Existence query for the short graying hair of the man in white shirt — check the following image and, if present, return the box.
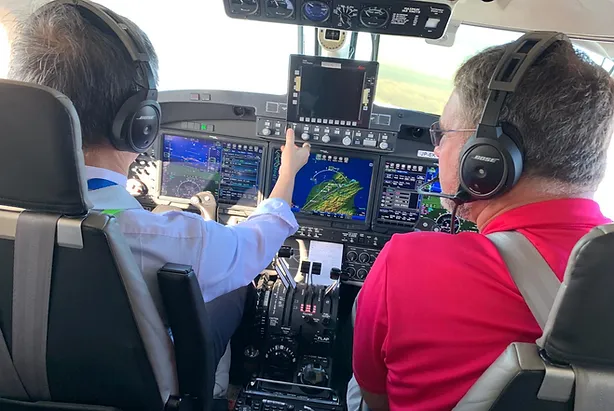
[9,4,158,147]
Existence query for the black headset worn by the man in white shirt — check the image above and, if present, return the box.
[48,0,161,153]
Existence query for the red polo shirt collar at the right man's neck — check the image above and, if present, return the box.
[482,198,610,234]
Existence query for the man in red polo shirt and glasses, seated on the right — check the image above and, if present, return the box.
[353,37,614,411]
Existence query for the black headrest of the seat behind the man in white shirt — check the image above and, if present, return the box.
[0,80,89,215]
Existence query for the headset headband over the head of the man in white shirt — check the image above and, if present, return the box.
[47,0,158,94]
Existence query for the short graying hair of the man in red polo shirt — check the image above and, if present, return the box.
[455,42,614,191]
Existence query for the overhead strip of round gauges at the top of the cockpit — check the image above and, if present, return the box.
[223,0,452,39]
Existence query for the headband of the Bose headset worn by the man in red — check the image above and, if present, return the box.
[476,32,570,138]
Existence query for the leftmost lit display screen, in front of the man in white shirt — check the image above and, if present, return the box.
[160,134,263,207]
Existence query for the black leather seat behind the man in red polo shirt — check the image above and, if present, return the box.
[455,224,614,411]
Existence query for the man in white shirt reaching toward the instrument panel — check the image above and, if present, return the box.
[8,2,309,400]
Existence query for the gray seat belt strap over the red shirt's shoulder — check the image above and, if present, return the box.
[486,231,561,330]
